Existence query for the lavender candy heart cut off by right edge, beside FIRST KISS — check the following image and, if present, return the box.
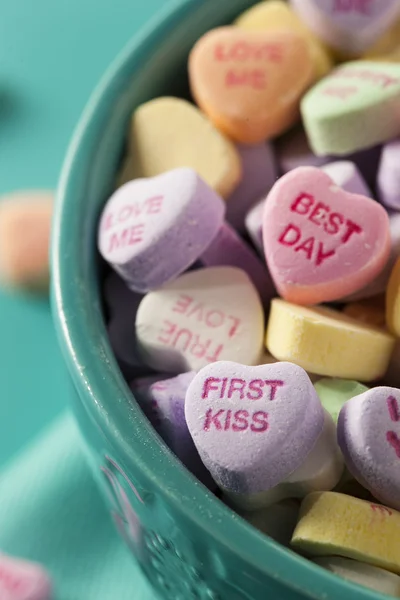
[337,387,400,510]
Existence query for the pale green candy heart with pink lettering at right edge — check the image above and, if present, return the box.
[301,61,400,155]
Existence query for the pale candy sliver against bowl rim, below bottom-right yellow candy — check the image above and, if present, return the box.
[314,556,400,597]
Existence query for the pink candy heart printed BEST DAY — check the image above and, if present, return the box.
[263,167,390,305]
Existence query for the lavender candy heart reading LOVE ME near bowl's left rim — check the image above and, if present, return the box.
[98,168,225,293]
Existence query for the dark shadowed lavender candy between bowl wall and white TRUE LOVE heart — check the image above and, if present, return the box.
[104,272,152,379]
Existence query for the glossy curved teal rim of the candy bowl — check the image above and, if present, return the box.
[51,0,386,600]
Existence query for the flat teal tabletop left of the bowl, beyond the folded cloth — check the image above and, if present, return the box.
[0,0,169,467]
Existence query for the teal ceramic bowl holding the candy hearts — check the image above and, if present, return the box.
[52,0,384,600]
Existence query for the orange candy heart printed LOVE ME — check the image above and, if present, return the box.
[189,27,314,144]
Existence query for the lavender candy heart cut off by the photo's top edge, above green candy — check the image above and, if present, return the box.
[290,0,400,55]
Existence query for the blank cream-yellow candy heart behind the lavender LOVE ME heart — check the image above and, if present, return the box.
[125,97,241,198]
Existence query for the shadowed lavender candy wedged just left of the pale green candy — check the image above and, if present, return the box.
[276,127,330,174]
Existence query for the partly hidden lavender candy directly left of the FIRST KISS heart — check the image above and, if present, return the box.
[131,371,216,489]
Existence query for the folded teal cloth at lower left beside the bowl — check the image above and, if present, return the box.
[0,414,155,600]
